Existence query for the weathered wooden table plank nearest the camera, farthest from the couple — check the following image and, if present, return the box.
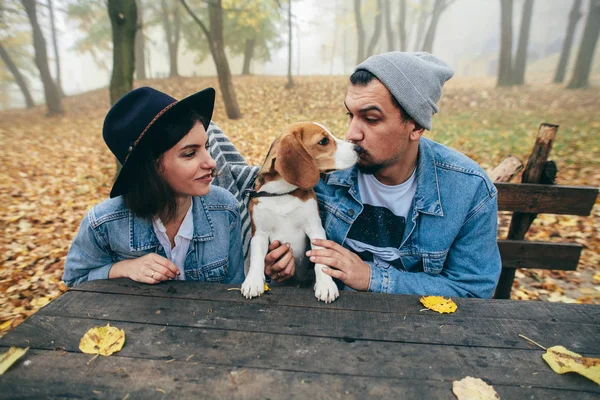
[0,350,598,400]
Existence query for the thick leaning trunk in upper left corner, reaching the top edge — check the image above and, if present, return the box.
[21,0,63,115]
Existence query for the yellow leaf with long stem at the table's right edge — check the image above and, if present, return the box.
[542,346,600,385]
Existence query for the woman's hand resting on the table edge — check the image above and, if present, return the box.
[108,253,179,285]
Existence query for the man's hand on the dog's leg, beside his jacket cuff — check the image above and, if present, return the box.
[306,239,371,291]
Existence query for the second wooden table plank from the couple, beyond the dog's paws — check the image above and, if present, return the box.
[29,292,600,353]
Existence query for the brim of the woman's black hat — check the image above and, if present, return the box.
[110,88,215,198]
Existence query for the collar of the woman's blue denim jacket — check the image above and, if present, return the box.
[129,197,214,251]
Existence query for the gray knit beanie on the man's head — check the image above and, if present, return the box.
[355,51,454,130]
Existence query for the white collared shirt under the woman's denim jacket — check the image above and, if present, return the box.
[152,204,194,281]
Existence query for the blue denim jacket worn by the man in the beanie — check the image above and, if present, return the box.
[315,138,501,298]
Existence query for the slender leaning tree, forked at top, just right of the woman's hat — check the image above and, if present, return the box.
[181,0,242,119]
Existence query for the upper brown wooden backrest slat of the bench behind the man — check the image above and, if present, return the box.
[495,183,598,216]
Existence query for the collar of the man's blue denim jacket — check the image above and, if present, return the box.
[325,137,444,217]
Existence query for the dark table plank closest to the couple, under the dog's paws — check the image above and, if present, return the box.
[68,279,600,324]
